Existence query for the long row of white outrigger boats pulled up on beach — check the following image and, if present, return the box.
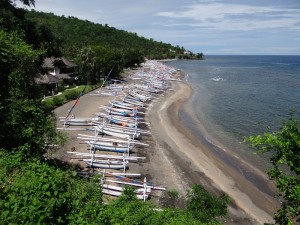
[61,61,180,201]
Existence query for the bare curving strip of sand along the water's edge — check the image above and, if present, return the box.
[149,74,277,224]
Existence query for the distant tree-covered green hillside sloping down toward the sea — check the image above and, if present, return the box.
[26,10,195,60]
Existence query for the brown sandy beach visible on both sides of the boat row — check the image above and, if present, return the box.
[55,63,278,224]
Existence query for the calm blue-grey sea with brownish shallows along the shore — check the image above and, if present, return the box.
[166,55,300,192]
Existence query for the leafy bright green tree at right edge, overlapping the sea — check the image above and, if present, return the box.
[245,114,300,225]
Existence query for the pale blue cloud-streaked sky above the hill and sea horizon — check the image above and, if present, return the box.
[18,0,300,55]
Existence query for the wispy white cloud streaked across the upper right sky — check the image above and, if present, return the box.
[157,2,300,30]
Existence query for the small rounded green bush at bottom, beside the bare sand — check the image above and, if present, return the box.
[187,184,230,223]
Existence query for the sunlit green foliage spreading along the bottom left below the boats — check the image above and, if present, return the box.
[0,151,226,225]
